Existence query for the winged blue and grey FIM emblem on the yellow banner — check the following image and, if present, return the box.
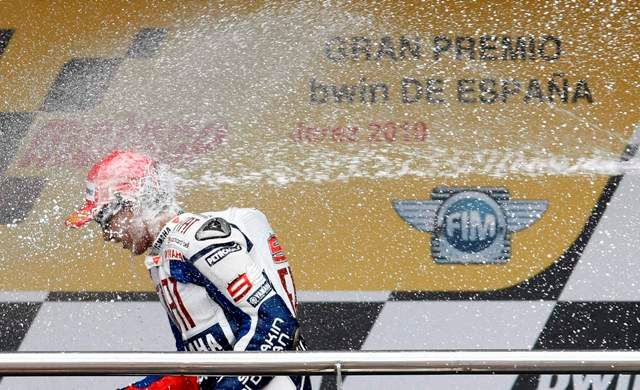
[393,187,549,264]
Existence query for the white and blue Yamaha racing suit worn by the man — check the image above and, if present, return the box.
[136,208,311,390]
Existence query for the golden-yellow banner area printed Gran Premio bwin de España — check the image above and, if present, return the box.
[0,1,640,299]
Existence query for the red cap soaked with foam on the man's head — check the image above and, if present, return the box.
[64,150,155,229]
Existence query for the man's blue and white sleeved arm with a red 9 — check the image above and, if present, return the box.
[190,222,298,389]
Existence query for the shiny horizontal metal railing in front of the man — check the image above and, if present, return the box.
[0,351,640,388]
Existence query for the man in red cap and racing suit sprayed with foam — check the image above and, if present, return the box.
[65,151,310,389]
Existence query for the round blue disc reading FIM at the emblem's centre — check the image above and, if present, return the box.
[443,196,499,253]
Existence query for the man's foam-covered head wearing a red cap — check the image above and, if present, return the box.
[65,150,178,255]
